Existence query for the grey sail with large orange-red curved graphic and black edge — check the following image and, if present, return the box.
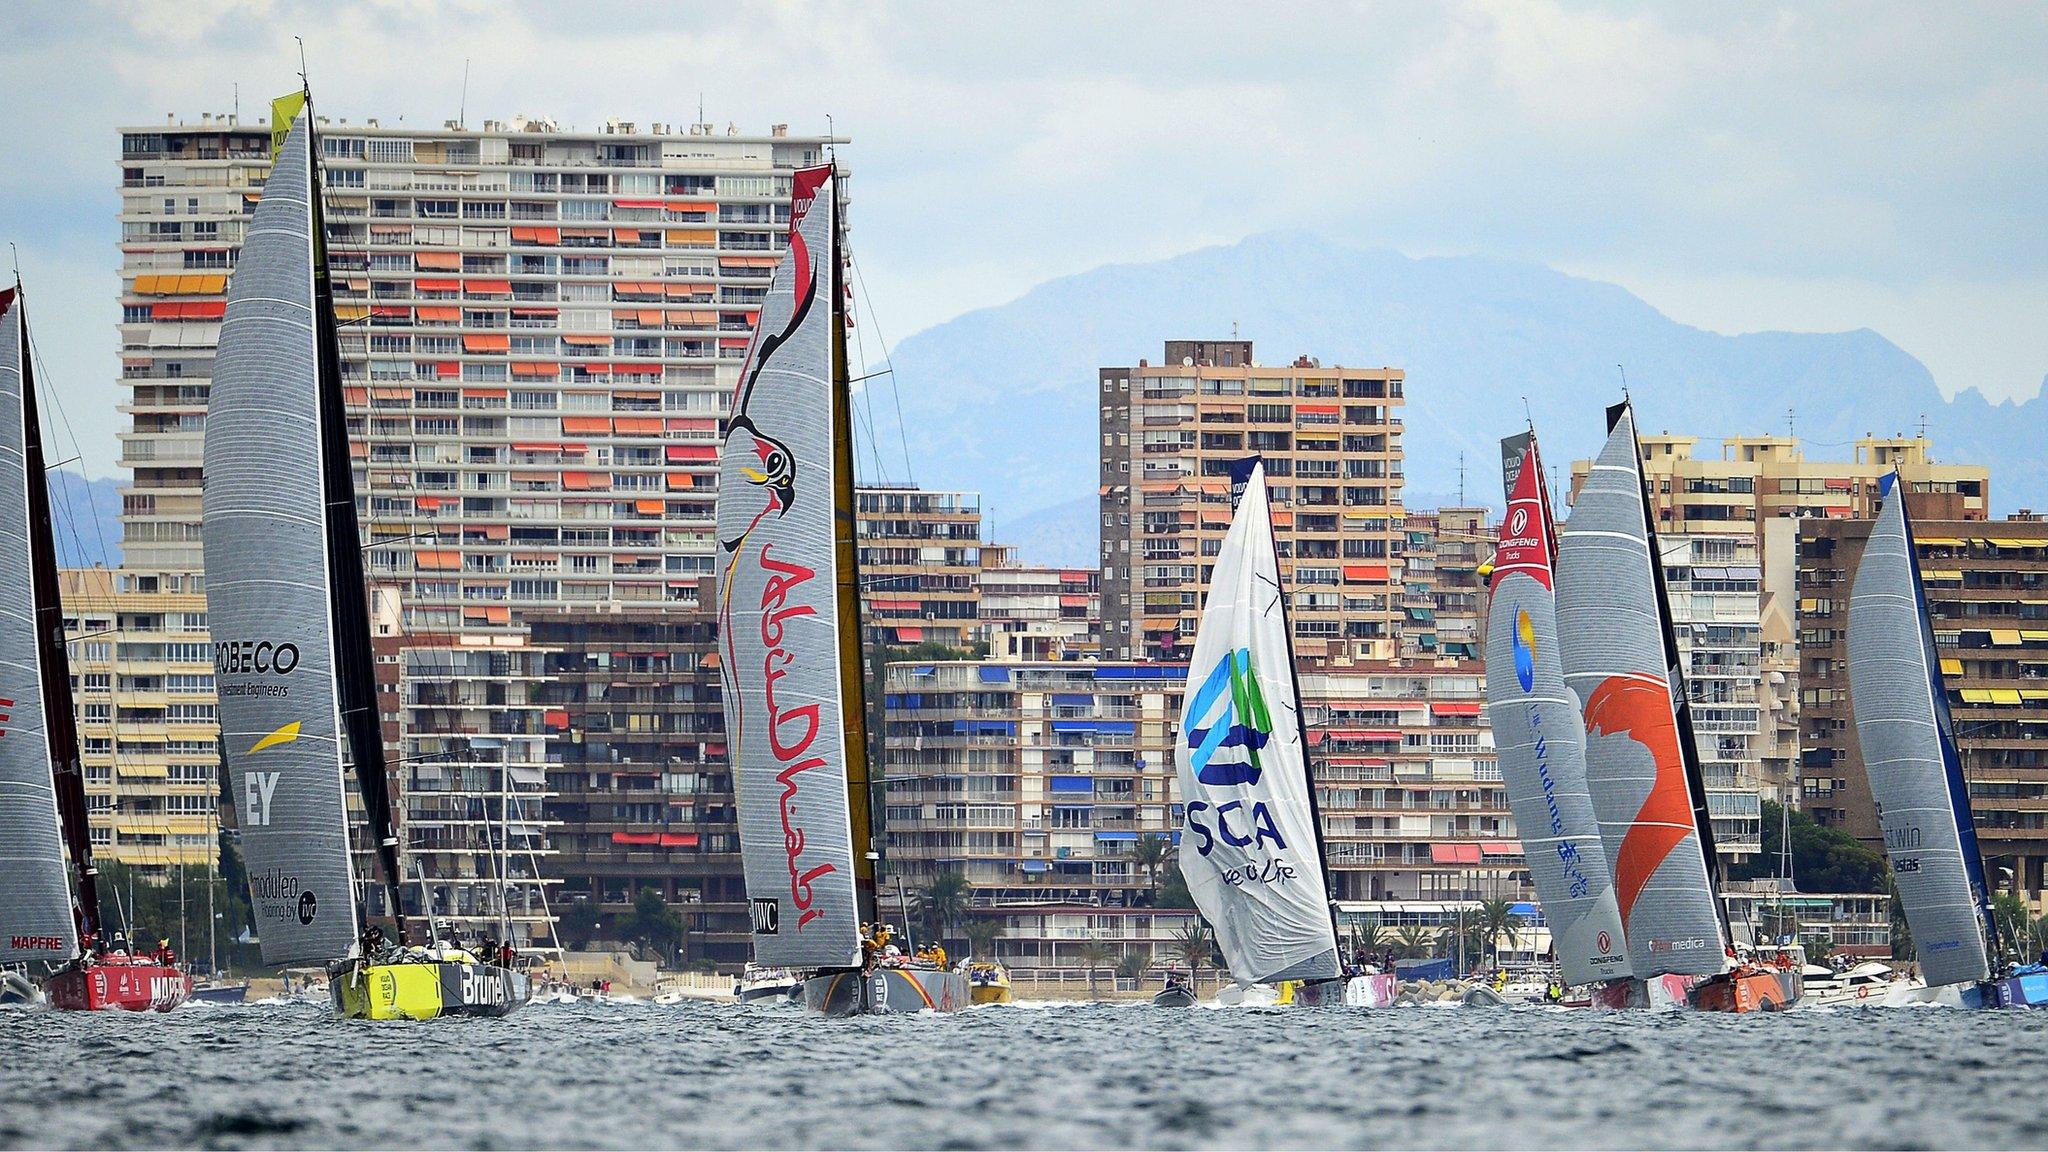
[1556,404,1729,978]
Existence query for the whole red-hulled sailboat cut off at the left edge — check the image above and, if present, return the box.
[0,281,193,1011]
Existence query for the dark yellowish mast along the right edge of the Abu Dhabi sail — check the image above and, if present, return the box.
[827,164,880,929]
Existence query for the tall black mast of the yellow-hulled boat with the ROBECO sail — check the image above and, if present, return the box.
[305,88,407,943]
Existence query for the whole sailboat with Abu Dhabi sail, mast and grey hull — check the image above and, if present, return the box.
[719,164,971,1017]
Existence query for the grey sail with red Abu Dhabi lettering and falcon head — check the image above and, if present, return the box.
[719,168,864,968]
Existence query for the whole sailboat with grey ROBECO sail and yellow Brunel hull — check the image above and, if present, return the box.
[203,90,532,1019]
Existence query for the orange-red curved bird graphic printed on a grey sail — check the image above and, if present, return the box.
[1585,676,1694,924]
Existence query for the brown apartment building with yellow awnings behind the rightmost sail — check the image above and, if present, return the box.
[1798,518,2048,900]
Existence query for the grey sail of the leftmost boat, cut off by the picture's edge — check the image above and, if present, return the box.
[0,289,90,963]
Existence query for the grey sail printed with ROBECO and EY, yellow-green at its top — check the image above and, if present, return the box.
[203,100,362,963]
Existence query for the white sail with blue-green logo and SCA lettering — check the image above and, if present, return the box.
[1174,457,1341,984]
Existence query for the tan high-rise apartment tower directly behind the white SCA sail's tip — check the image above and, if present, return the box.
[1098,340,1405,664]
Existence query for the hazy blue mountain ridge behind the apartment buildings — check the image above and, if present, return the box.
[870,232,2048,564]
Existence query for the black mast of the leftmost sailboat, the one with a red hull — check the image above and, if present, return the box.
[13,279,100,945]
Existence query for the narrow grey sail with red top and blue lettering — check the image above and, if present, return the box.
[1487,435,1630,984]
